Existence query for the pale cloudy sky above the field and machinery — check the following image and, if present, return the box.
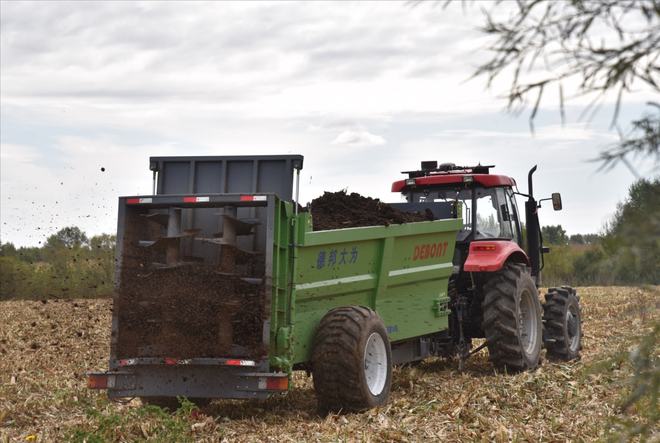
[0,1,657,246]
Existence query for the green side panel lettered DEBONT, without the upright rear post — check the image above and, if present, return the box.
[293,215,461,362]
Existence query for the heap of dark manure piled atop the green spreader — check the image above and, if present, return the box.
[311,191,433,231]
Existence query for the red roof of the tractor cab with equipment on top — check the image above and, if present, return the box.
[392,161,516,192]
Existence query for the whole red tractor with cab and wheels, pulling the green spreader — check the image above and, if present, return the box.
[392,161,582,372]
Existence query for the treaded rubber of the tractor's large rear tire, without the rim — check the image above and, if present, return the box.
[481,263,540,372]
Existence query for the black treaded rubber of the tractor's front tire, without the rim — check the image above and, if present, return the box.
[543,286,582,361]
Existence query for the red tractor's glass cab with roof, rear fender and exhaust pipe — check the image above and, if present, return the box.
[392,161,561,284]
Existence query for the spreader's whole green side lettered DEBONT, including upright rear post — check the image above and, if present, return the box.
[270,201,462,371]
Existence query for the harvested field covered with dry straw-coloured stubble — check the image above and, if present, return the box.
[0,287,660,442]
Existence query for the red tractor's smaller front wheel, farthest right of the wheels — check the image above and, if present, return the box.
[543,286,582,361]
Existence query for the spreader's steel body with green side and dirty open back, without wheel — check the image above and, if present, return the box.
[89,156,462,400]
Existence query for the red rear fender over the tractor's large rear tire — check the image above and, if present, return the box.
[463,240,530,272]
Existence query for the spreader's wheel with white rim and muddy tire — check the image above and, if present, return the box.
[312,306,392,414]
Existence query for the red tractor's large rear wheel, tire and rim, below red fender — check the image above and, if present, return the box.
[481,263,543,372]
